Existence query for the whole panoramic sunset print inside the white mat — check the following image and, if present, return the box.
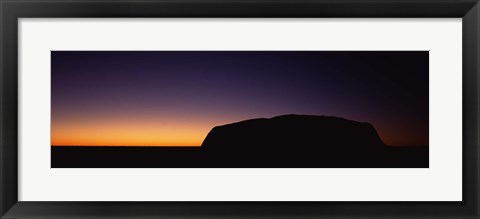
[51,51,429,168]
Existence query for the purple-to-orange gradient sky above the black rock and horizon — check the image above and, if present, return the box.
[51,51,428,146]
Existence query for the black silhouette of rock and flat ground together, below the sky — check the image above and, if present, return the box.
[52,115,429,168]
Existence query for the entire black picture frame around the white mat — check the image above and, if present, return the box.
[0,0,480,219]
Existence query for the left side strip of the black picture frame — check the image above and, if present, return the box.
[0,2,18,215]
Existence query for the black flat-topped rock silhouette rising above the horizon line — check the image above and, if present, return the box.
[202,115,384,150]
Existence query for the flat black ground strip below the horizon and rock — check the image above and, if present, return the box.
[51,146,429,168]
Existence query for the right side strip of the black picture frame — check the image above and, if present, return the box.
[462,3,480,217]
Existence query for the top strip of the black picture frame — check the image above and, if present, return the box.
[2,0,478,18]
